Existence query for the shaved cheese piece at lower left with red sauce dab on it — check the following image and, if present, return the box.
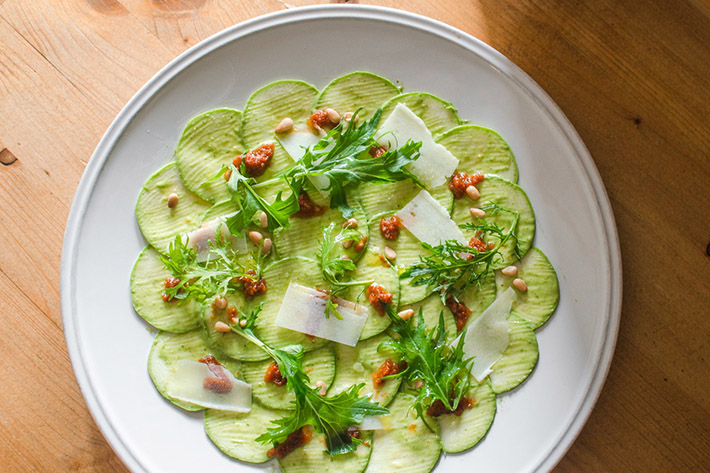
[166,360,251,412]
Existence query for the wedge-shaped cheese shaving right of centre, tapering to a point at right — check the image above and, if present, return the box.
[396,190,466,246]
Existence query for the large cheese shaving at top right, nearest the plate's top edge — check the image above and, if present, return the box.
[377,103,459,187]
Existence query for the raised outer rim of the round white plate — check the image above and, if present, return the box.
[60,5,622,473]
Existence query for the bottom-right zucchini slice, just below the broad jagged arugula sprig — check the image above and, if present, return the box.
[436,380,497,453]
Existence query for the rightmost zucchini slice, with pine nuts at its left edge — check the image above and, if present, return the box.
[496,247,560,329]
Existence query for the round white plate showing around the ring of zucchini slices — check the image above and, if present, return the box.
[61,5,621,473]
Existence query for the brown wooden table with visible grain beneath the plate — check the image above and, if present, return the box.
[0,0,710,472]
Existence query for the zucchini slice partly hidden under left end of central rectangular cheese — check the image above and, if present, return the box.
[249,256,328,351]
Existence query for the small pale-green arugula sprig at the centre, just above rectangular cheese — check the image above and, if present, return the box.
[316,222,373,319]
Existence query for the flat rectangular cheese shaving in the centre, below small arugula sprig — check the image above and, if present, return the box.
[276,282,367,347]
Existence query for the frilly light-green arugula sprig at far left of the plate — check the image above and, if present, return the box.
[158,227,263,302]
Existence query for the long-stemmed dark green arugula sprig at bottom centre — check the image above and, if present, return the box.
[231,306,389,455]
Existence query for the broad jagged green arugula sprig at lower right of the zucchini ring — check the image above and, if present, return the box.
[382,307,473,423]
